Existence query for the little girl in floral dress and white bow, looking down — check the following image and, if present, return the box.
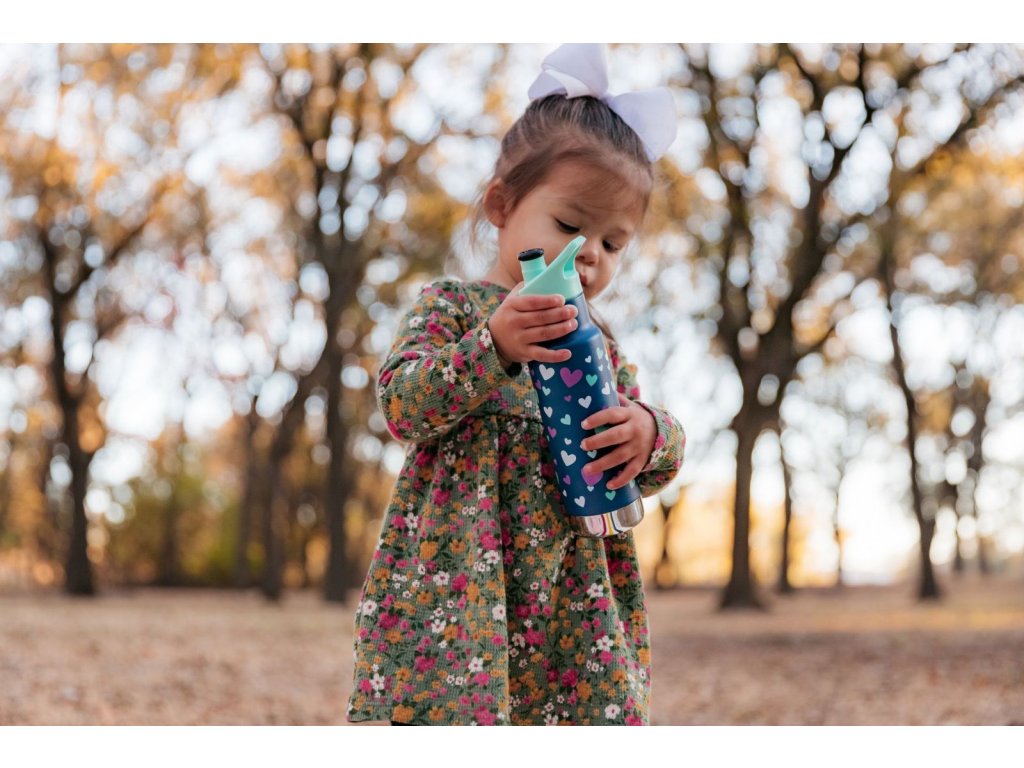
[348,45,685,725]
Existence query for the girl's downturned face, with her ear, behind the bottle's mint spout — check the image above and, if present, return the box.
[484,161,643,300]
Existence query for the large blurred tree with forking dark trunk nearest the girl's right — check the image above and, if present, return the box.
[680,44,1020,607]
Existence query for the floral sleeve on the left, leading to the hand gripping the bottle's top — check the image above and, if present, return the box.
[377,280,514,442]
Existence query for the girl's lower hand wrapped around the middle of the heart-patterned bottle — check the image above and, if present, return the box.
[580,392,657,490]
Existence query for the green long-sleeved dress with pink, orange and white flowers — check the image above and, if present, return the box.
[347,280,685,725]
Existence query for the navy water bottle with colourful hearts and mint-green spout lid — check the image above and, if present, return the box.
[519,237,643,539]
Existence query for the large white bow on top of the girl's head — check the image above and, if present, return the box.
[528,43,676,163]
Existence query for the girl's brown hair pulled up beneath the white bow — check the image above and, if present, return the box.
[468,94,654,339]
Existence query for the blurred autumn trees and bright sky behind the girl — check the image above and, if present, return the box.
[0,44,1024,723]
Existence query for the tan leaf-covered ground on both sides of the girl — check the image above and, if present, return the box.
[0,577,1024,725]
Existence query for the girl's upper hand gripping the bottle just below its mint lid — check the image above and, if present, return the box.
[487,283,577,362]
